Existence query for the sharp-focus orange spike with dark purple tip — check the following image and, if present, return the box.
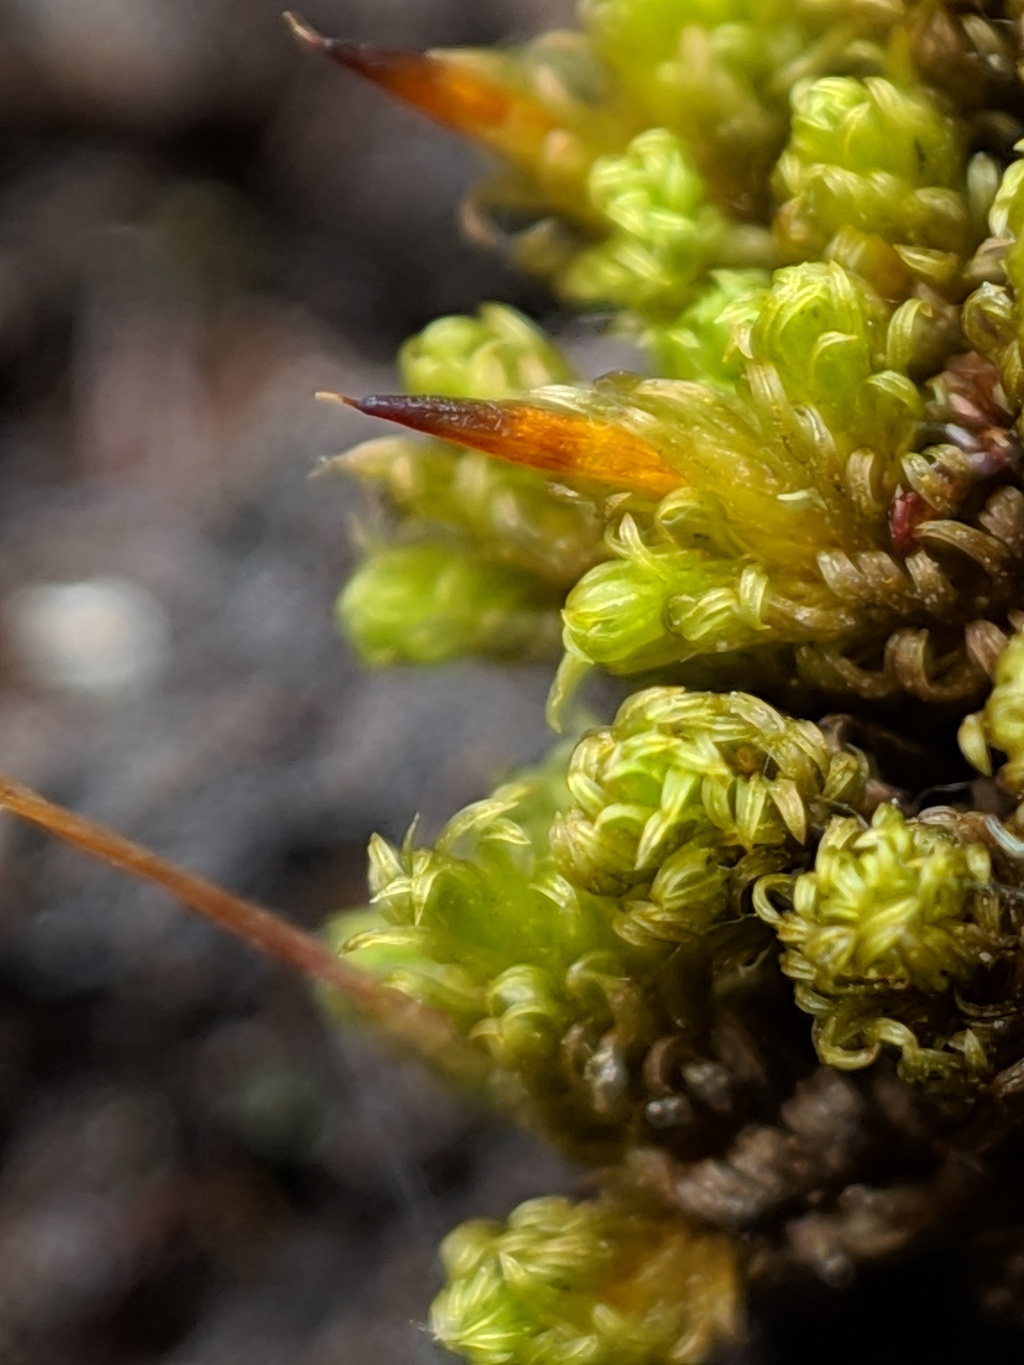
[344,393,683,497]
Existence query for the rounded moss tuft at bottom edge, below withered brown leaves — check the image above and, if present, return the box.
[430,1197,740,1365]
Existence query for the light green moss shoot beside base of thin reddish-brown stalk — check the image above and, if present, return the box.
[333,751,638,1144]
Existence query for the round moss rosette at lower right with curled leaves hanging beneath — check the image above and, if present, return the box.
[755,805,1008,1080]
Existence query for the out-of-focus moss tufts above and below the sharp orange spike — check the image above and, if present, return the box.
[337,303,602,665]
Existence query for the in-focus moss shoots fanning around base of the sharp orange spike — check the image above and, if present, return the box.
[565,263,945,693]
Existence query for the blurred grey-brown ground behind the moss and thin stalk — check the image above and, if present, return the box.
[0,0,584,1365]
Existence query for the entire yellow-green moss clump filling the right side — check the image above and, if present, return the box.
[320,0,1024,1365]
